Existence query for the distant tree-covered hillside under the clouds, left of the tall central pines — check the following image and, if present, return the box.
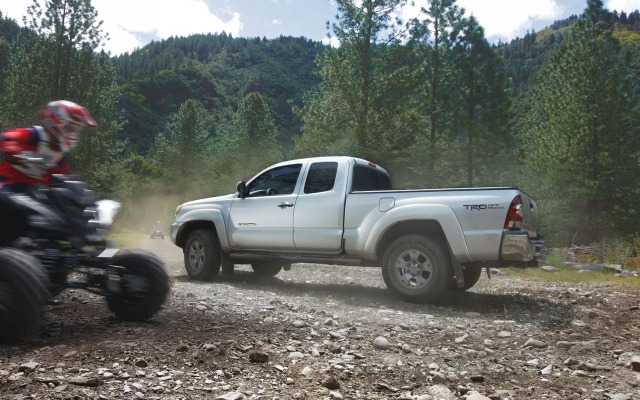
[113,33,322,154]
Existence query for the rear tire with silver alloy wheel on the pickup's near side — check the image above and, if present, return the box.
[382,235,453,303]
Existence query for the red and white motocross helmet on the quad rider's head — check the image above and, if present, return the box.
[40,100,97,149]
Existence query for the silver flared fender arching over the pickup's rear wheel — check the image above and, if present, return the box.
[364,204,471,263]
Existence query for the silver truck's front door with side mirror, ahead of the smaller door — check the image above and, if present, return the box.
[229,164,302,250]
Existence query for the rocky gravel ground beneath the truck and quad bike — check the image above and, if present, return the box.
[0,239,640,400]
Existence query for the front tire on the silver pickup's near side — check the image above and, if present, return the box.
[183,229,221,281]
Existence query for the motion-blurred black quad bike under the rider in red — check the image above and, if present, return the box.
[0,171,169,342]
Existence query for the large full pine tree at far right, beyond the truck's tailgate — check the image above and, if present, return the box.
[524,0,640,244]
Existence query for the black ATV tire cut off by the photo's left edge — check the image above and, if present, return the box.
[0,248,50,342]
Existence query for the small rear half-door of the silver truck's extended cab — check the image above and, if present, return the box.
[293,161,348,254]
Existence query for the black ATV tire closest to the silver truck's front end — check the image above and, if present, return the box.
[107,250,169,321]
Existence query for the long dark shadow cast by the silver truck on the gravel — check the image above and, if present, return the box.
[175,271,576,329]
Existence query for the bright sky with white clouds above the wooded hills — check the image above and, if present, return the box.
[0,0,640,56]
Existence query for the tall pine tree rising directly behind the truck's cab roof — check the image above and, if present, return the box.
[296,0,410,160]
